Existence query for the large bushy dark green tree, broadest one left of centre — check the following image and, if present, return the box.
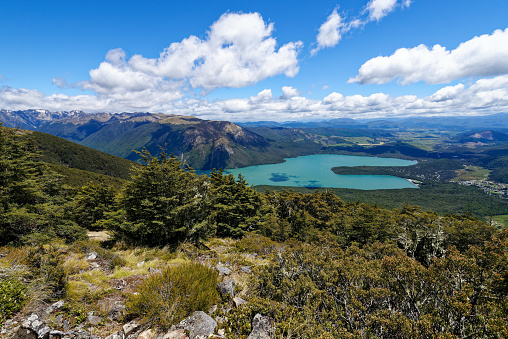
[103,150,211,246]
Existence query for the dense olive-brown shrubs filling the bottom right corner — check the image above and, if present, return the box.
[251,238,508,338]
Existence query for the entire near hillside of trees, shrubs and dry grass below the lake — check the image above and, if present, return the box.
[0,126,508,338]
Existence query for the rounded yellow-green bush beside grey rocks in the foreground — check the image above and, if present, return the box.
[127,262,219,329]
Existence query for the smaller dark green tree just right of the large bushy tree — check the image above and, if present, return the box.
[208,170,264,238]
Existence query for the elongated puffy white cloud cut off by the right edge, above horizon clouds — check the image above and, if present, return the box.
[348,28,508,85]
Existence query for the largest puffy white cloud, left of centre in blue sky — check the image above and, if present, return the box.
[81,13,302,94]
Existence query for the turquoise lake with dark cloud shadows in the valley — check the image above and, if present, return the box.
[225,154,417,190]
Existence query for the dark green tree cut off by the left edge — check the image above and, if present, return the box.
[0,124,86,245]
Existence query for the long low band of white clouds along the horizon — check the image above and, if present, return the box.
[0,75,508,121]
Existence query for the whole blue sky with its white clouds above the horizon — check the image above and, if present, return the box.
[0,0,508,122]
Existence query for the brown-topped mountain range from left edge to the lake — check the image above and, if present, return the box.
[0,110,283,169]
